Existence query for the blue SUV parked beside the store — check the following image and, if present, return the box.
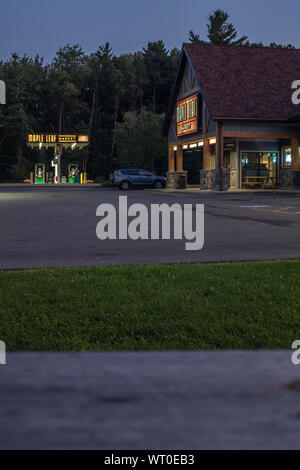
[110,168,167,190]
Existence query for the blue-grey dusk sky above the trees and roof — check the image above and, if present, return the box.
[0,0,300,61]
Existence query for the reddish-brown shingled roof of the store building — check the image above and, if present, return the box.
[176,43,300,120]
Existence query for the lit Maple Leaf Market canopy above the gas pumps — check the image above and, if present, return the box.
[27,134,89,148]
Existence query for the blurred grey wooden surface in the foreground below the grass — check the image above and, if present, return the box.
[0,351,300,449]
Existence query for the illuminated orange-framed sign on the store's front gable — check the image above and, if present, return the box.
[177,95,199,136]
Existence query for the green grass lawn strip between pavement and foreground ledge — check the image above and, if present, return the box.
[0,261,300,351]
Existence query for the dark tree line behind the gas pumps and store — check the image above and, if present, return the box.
[0,10,293,182]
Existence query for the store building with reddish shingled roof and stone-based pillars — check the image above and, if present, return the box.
[165,44,300,191]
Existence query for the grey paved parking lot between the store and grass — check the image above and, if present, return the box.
[0,187,300,269]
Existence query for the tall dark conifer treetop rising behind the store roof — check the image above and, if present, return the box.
[189,9,247,46]
